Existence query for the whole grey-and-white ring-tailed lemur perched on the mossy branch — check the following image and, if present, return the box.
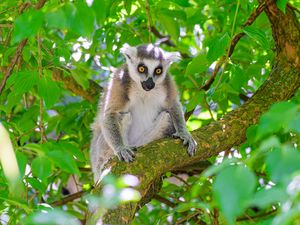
[90,44,197,182]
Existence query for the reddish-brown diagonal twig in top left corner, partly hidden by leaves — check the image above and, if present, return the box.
[0,0,46,95]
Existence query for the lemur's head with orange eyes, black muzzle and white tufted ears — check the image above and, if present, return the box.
[121,44,180,91]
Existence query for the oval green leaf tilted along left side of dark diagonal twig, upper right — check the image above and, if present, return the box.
[207,33,230,62]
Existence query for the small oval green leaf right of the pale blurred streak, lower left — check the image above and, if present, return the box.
[31,156,52,182]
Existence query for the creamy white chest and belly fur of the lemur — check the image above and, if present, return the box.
[126,84,166,146]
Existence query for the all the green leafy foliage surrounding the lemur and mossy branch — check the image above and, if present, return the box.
[0,0,300,224]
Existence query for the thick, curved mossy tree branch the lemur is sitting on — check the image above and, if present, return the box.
[88,0,300,225]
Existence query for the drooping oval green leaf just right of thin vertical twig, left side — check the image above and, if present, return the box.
[38,77,61,108]
